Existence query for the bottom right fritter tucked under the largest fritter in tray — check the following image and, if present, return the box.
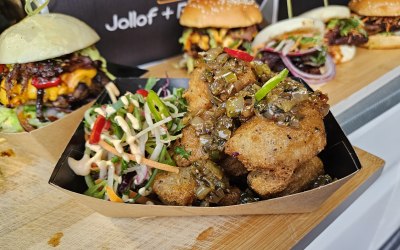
[247,157,324,198]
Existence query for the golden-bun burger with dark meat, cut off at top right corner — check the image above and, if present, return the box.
[349,0,400,49]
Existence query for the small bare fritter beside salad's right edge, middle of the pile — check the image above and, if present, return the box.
[172,125,208,167]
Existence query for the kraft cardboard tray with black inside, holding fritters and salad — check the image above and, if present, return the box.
[49,78,361,217]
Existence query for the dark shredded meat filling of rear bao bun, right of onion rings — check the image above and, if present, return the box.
[325,27,368,46]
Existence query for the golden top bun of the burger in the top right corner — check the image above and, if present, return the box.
[349,0,400,16]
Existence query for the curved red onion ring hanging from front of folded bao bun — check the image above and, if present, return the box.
[279,55,336,84]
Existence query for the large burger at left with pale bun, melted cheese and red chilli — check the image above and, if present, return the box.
[0,13,114,133]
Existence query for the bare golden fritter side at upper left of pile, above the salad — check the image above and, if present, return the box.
[183,67,212,116]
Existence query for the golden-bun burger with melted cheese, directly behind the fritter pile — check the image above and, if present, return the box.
[179,0,263,72]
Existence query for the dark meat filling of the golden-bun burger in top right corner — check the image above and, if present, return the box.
[361,16,400,35]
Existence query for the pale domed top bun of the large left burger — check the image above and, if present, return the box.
[0,13,100,64]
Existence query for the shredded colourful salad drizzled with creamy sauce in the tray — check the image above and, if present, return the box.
[68,79,187,204]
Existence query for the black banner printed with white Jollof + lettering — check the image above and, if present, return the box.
[49,0,186,66]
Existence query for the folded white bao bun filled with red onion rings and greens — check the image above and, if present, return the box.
[252,17,335,84]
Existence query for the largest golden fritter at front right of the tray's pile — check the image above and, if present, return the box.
[225,104,326,171]
